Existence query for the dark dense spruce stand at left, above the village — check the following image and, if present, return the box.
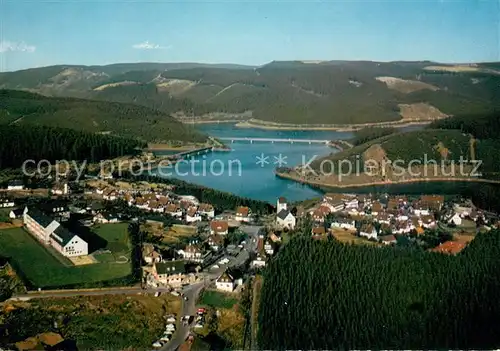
[0,124,144,168]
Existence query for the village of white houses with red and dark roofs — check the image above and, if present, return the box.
[0,177,498,348]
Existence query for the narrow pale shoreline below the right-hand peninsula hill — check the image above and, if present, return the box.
[274,171,500,189]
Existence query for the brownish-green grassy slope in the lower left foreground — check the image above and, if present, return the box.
[0,294,181,350]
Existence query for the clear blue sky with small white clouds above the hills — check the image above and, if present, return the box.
[0,0,500,71]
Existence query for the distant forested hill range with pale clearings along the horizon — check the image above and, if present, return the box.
[0,61,500,124]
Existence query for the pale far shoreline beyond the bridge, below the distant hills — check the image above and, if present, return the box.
[235,120,433,132]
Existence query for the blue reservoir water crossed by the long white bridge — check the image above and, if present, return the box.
[160,124,421,203]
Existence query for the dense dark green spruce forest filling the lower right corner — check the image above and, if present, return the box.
[258,230,500,350]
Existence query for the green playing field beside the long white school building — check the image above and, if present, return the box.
[0,224,131,288]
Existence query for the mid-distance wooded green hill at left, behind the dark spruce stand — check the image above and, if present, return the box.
[0,90,206,142]
